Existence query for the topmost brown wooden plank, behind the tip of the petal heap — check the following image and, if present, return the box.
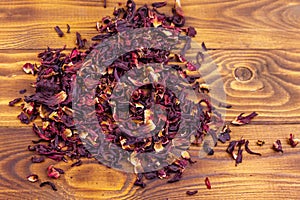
[0,0,300,49]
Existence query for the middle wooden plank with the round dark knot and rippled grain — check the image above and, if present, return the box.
[0,50,300,126]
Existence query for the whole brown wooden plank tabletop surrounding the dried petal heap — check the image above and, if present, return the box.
[0,0,300,199]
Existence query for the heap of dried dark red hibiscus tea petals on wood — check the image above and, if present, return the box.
[18,0,225,190]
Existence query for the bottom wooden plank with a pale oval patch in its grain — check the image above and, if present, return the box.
[0,124,300,199]
